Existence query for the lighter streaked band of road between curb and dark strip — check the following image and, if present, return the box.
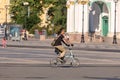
[0,47,120,66]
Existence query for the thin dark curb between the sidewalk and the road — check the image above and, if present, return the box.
[0,44,120,52]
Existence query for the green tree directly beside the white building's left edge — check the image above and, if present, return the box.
[42,0,67,32]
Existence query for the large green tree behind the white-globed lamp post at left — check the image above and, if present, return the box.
[10,0,42,30]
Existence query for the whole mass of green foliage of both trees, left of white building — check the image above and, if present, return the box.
[10,0,67,34]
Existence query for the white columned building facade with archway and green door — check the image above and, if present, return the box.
[66,0,120,38]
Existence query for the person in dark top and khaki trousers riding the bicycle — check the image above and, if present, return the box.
[54,28,70,61]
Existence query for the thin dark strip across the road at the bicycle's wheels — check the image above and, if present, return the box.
[0,63,120,68]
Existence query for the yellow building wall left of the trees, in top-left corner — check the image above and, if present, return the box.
[0,0,10,24]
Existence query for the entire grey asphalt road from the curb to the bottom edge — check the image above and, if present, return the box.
[0,48,120,80]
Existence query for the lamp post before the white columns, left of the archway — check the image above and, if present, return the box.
[78,0,89,43]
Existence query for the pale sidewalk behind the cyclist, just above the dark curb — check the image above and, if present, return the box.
[0,39,120,50]
